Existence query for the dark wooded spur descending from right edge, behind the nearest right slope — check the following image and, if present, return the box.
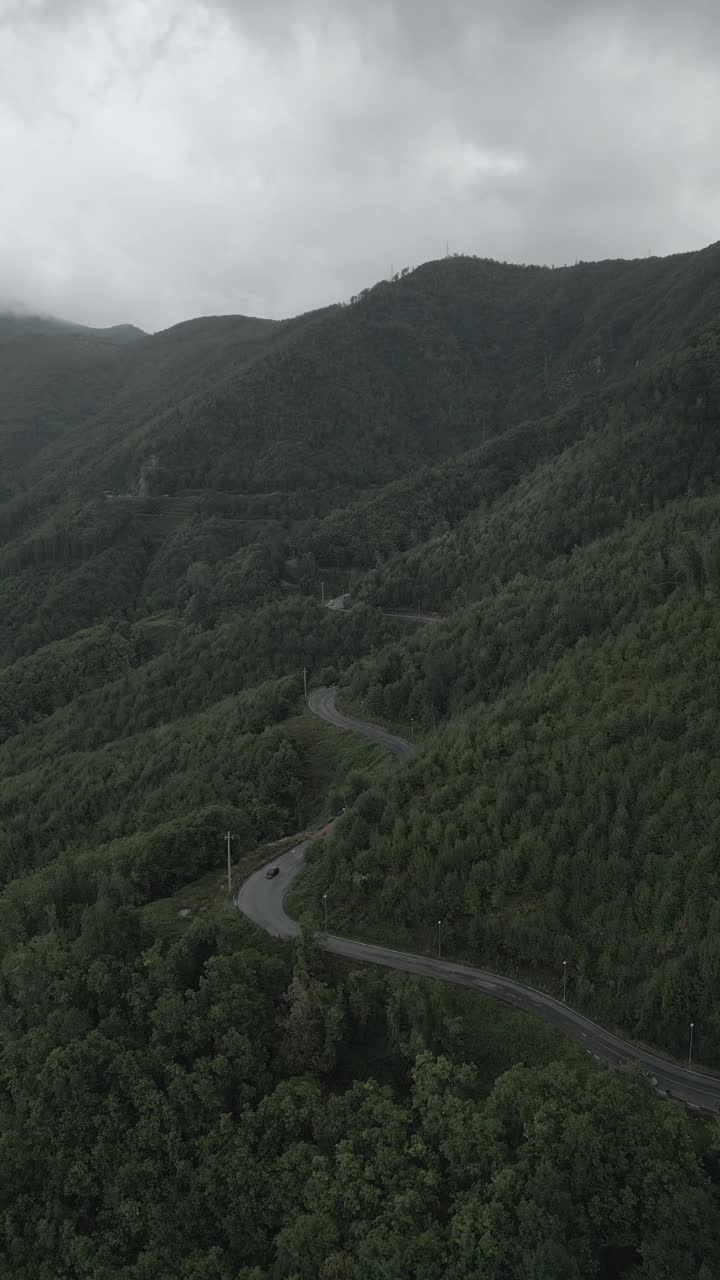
[310,317,720,583]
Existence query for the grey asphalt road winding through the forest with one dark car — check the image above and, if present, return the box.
[236,689,720,1111]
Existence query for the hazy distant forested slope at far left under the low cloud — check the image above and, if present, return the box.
[0,309,289,502]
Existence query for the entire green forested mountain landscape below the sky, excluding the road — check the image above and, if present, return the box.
[0,246,720,1280]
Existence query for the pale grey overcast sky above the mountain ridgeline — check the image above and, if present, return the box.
[0,0,720,330]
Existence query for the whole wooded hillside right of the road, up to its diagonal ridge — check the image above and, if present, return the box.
[292,330,720,1061]
